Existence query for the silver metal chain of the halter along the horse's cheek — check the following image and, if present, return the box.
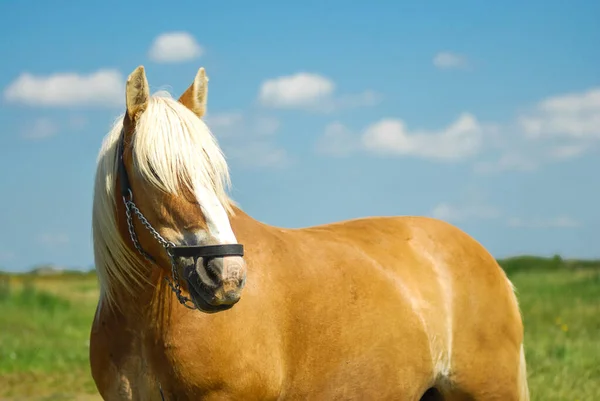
[123,190,196,309]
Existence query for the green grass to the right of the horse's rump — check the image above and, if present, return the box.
[502,258,600,401]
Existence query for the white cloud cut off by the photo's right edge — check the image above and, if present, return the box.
[519,88,600,139]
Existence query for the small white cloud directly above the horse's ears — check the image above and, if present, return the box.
[148,32,204,63]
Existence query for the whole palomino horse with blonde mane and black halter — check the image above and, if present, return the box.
[90,67,529,401]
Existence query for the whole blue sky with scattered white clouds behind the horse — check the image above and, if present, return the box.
[0,1,600,270]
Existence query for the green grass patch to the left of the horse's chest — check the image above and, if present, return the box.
[0,275,97,400]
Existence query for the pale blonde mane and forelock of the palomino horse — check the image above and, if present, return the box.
[92,92,233,306]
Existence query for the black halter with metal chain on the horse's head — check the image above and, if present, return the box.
[117,131,244,309]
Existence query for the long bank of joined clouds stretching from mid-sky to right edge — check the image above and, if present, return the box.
[315,84,600,170]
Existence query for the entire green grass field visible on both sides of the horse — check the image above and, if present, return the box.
[0,257,600,401]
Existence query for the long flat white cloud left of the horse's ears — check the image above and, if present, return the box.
[4,69,125,107]
